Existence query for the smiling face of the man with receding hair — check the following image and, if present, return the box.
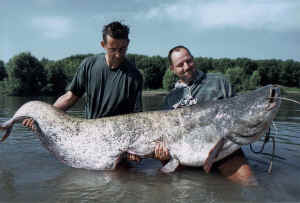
[170,48,196,83]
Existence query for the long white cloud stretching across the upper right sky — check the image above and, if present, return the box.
[138,0,300,31]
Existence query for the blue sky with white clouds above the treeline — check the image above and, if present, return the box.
[0,0,300,62]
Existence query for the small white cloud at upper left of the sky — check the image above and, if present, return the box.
[32,16,72,39]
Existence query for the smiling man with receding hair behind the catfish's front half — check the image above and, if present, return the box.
[156,46,256,184]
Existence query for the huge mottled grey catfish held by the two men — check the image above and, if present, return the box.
[0,85,281,172]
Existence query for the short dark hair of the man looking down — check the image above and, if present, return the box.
[102,21,129,43]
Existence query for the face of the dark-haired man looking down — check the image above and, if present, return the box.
[101,35,129,68]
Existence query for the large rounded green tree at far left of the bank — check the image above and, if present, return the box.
[4,52,47,96]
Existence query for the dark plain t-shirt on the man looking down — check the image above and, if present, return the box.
[67,54,143,118]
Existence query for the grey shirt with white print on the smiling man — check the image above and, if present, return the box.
[164,71,234,109]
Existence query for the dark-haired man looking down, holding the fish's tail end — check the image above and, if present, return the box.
[23,22,143,160]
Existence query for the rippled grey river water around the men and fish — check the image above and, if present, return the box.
[0,94,300,203]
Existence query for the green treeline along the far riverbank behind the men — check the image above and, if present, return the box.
[0,52,300,96]
